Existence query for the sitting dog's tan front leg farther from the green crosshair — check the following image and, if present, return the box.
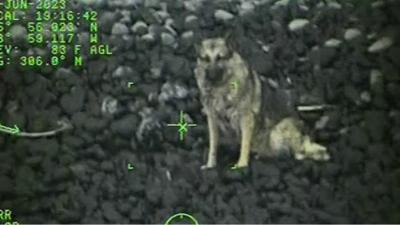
[236,113,255,167]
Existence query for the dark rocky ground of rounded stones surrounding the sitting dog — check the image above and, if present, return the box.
[0,0,400,224]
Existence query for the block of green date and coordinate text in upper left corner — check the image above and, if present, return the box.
[0,0,112,68]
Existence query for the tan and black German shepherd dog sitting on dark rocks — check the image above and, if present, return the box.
[194,38,330,169]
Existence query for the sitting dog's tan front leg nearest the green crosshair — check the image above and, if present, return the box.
[201,111,218,169]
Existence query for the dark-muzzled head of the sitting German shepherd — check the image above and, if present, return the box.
[197,38,233,85]
